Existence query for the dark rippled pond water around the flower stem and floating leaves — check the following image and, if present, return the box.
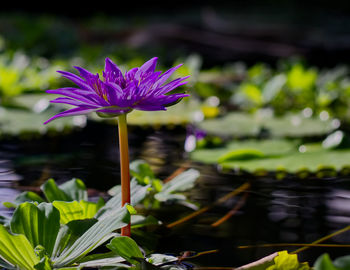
[0,122,350,266]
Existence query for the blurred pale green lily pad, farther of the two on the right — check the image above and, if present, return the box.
[198,112,339,138]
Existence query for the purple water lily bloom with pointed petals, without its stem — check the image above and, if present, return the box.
[44,57,189,124]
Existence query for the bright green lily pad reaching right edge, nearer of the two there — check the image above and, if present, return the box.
[190,139,350,173]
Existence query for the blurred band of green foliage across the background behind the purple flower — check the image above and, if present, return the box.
[0,15,350,133]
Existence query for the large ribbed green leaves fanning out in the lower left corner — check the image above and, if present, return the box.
[0,202,130,270]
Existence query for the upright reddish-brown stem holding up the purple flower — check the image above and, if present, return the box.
[118,114,131,236]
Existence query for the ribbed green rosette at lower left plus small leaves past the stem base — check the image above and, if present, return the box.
[0,199,189,270]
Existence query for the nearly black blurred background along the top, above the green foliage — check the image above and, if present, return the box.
[0,0,350,67]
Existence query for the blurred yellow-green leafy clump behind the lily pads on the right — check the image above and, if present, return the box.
[230,60,350,118]
